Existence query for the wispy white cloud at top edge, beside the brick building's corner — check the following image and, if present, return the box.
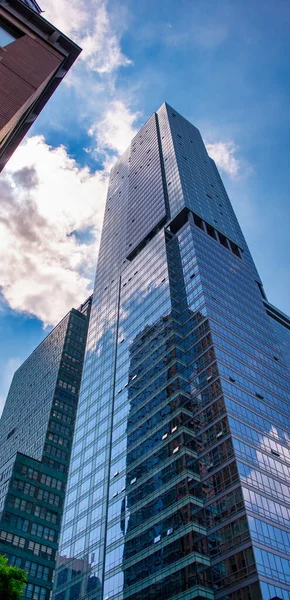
[43,0,131,74]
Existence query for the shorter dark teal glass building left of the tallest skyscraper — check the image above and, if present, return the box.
[0,298,91,600]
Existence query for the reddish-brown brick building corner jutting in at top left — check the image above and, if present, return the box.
[0,0,81,172]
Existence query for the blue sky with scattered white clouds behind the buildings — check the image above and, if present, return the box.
[0,0,290,410]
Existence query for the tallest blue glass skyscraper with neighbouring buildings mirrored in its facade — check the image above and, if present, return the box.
[53,104,290,600]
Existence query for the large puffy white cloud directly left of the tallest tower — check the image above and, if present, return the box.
[0,136,107,324]
